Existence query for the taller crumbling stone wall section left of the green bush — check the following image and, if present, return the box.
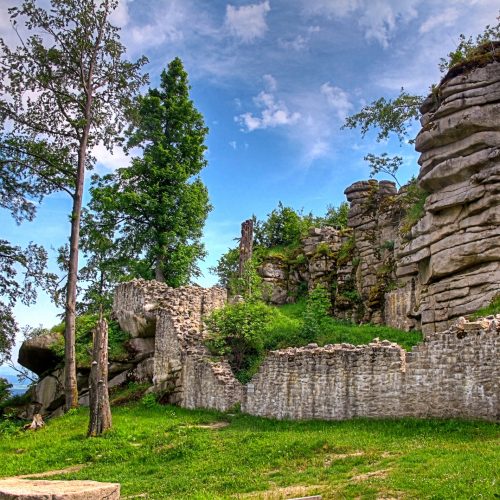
[114,280,242,411]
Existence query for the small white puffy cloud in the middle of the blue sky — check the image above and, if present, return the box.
[235,91,300,132]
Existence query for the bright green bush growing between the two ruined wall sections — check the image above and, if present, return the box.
[205,302,274,382]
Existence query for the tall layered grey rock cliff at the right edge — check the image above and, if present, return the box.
[397,62,500,332]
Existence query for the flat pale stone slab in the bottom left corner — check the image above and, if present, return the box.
[0,479,120,500]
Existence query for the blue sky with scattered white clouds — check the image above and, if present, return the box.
[0,0,498,336]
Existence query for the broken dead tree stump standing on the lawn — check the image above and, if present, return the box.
[87,313,111,437]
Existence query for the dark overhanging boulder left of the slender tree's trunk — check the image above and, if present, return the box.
[17,332,62,375]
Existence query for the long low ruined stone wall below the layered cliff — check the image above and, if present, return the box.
[242,315,500,420]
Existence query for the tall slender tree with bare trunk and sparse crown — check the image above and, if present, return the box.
[0,0,145,409]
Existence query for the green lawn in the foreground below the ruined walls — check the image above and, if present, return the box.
[0,403,500,500]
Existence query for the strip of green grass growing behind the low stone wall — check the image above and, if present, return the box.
[265,300,422,350]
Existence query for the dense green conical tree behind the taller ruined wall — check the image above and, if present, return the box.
[89,58,211,287]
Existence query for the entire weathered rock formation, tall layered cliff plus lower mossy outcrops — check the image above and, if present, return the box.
[261,58,500,333]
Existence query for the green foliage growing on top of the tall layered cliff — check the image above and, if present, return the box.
[439,15,500,73]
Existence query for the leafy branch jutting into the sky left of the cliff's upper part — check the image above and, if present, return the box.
[342,88,423,143]
